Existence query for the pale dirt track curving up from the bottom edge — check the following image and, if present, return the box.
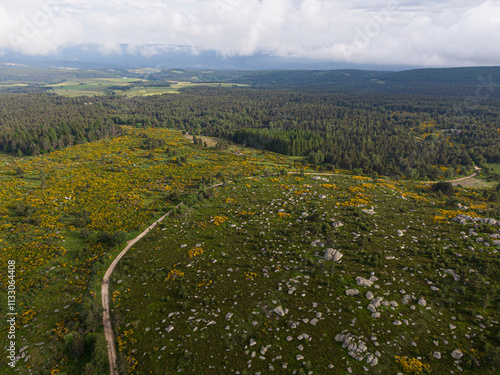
[101,203,182,375]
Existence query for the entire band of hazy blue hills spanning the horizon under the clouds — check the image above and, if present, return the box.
[0,61,500,99]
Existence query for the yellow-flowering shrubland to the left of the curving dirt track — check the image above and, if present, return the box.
[0,127,293,374]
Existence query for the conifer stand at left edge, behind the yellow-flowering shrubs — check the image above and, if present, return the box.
[0,94,121,156]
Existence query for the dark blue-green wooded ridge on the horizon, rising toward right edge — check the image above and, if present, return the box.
[144,67,500,99]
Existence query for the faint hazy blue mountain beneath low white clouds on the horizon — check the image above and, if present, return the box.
[0,44,409,71]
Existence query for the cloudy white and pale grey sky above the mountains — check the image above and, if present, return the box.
[0,0,500,67]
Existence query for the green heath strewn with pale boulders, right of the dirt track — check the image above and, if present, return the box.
[110,175,500,374]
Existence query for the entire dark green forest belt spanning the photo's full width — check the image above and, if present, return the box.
[0,87,500,179]
